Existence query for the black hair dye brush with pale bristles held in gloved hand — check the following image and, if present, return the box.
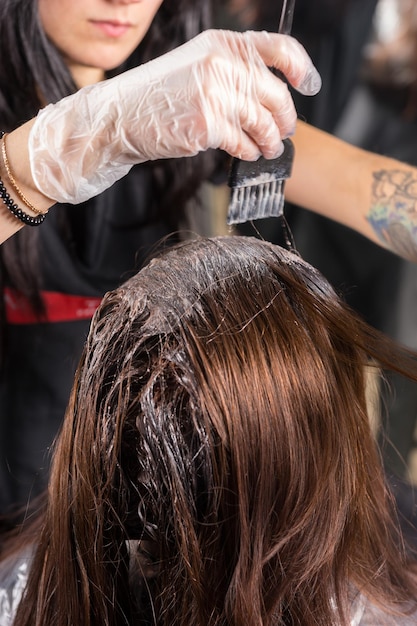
[227,0,295,224]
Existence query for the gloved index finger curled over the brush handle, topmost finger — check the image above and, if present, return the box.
[243,31,321,95]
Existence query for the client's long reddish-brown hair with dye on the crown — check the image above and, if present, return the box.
[11,237,417,626]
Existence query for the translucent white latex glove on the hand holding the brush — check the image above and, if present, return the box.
[29,30,321,204]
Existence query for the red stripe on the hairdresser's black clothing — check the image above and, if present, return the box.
[4,287,101,324]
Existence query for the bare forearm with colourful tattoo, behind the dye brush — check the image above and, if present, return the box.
[286,122,417,262]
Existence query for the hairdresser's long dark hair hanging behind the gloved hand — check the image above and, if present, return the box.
[0,0,214,312]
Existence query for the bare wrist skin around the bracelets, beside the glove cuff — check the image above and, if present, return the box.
[0,121,55,243]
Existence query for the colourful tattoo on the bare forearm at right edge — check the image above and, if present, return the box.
[366,170,417,262]
